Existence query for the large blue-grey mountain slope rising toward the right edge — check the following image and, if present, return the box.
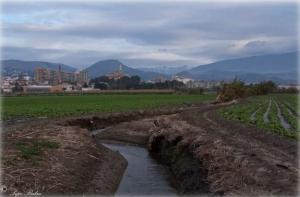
[178,52,298,84]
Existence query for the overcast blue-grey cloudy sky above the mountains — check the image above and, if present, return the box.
[1,1,298,68]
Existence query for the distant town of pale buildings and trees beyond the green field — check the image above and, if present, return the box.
[0,64,222,95]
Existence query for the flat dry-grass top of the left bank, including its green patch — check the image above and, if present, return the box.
[2,125,101,194]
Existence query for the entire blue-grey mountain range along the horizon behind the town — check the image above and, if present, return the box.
[1,52,298,84]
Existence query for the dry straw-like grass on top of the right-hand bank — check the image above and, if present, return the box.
[145,109,298,195]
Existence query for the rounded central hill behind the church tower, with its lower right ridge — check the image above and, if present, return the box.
[85,60,169,80]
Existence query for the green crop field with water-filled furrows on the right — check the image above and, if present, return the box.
[218,94,299,139]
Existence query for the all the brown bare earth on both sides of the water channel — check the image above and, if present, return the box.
[2,104,299,196]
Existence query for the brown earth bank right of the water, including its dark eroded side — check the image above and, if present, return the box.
[97,105,299,196]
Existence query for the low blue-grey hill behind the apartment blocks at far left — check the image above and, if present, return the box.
[1,60,76,76]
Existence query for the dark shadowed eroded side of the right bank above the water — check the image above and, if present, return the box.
[148,133,210,194]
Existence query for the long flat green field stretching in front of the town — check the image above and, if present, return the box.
[2,93,215,120]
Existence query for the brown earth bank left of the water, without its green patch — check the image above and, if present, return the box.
[2,122,127,195]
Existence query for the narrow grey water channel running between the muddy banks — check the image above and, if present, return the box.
[102,143,176,196]
